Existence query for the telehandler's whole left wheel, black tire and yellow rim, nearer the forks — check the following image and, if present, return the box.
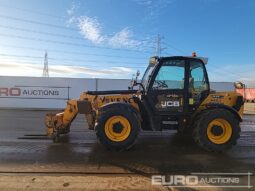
[96,103,140,151]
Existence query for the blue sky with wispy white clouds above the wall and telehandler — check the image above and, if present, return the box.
[0,0,255,84]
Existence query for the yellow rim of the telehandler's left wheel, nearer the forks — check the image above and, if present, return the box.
[104,116,131,142]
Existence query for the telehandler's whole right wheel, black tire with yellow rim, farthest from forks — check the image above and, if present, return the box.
[193,109,240,152]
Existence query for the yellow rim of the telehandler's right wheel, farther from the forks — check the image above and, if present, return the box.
[207,119,232,144]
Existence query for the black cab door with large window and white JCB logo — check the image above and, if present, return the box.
[147,58,188,116]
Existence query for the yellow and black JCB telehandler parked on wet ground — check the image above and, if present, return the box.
[45,56,244,151]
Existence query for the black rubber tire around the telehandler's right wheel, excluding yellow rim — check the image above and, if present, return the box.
[193,109,241,152]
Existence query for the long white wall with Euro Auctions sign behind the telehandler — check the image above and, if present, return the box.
[0,76,234,109]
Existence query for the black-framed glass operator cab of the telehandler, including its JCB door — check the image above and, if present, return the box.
[142,56,210,131]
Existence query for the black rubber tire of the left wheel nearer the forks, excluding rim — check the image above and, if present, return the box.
[96,103,141,151]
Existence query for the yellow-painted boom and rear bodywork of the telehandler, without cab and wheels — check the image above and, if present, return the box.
[45,92,244,135]
